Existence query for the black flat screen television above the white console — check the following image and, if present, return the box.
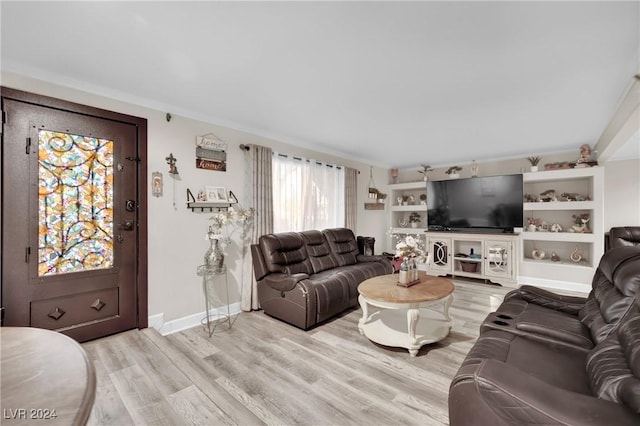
[427,174,523,232]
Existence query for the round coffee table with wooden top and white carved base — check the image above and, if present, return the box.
[358,272,455,356]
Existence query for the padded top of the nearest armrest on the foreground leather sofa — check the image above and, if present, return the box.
[452,359,640,426]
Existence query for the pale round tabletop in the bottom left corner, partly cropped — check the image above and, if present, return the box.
[0,327,96,425]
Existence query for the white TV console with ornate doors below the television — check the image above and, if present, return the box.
[425,232,521,288]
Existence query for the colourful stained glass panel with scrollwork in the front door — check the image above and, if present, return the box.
[38,130,114,276]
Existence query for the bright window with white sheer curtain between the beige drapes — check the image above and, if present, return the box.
[272,153,345,232]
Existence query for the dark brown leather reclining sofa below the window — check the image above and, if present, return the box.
[251,228,393,330]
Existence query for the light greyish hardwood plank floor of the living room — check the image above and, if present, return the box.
[83,280,509,425]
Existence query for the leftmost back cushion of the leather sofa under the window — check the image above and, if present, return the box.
[258,232,313,275]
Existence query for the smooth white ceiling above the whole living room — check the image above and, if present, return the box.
[0,1,640,167]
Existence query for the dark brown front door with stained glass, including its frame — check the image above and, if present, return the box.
[2,89,146,341]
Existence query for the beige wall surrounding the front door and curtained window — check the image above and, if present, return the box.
[1,72,387,322]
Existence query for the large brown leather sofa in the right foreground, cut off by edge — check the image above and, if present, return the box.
[449,246,640,426]
